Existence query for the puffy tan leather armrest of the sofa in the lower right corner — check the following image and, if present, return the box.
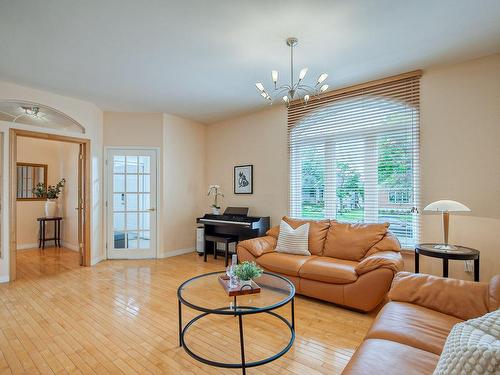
[388,272,490,320]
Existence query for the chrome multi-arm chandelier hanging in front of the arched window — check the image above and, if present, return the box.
[255,38,328,106]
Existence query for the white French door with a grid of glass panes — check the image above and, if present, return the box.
[107,149,158,259]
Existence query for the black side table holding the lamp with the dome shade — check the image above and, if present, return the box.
[415,243,479,281]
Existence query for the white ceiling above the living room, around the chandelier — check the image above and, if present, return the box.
[0,0,500,123]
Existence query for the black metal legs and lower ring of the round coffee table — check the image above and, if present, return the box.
[179,298,295,374]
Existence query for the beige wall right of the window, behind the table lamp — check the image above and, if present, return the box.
[421,54,500,280]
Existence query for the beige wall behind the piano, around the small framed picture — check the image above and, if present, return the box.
[205,105,288,225]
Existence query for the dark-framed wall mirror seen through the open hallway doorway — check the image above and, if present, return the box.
[17,163,47,201]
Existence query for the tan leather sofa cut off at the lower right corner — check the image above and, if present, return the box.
[343,272,500,375]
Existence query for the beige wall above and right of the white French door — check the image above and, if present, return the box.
[103,112,205,257]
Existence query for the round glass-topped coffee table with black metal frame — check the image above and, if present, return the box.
[177,272,295,374]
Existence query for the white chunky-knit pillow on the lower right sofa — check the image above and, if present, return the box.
[434,310,500,375]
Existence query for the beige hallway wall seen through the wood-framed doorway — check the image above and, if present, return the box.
[16,137,78,250]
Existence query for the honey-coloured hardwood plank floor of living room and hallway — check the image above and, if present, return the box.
[0,249,373,375]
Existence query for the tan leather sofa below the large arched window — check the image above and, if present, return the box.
[237,217,403,311]
